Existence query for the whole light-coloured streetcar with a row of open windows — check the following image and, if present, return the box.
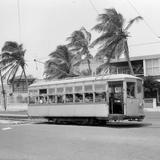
[28,74,145,123]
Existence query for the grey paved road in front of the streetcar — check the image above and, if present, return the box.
[0,113,160,160]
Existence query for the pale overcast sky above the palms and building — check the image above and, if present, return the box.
[0,0,160,78]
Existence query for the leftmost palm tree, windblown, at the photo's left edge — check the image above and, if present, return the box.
[0,41,28,110]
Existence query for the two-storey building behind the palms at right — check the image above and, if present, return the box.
[80,54,160,106]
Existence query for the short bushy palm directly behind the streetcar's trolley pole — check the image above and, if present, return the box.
[44,45,79,79]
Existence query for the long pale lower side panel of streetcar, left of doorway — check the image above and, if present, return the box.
[28,104,108,117]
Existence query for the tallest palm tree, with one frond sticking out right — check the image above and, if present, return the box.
[91,8,143,74]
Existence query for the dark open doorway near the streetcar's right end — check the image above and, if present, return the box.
[108,81,124,114]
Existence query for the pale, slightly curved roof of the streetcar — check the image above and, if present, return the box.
[29,74,141,88]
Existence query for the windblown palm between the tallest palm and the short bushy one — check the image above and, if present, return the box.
[67,27,93,74]
